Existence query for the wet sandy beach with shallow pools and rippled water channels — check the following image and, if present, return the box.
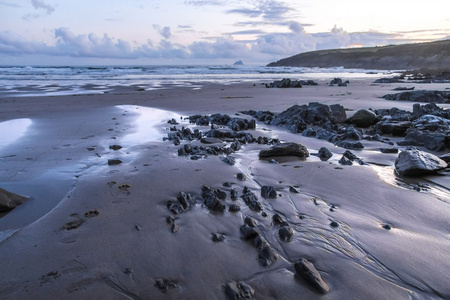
[0,79,450,299]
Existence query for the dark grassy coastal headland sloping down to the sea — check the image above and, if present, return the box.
[267,40,450,70]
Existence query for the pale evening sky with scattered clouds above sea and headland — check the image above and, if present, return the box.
[0,0,450,65]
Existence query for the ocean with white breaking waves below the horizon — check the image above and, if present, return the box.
[0,65,386,97]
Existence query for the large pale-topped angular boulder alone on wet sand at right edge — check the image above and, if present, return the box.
[395,147,447,176]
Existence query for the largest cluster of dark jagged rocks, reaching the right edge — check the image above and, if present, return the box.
[242,102,450,152]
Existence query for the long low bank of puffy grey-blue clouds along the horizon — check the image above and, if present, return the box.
[0,23,436,63]
